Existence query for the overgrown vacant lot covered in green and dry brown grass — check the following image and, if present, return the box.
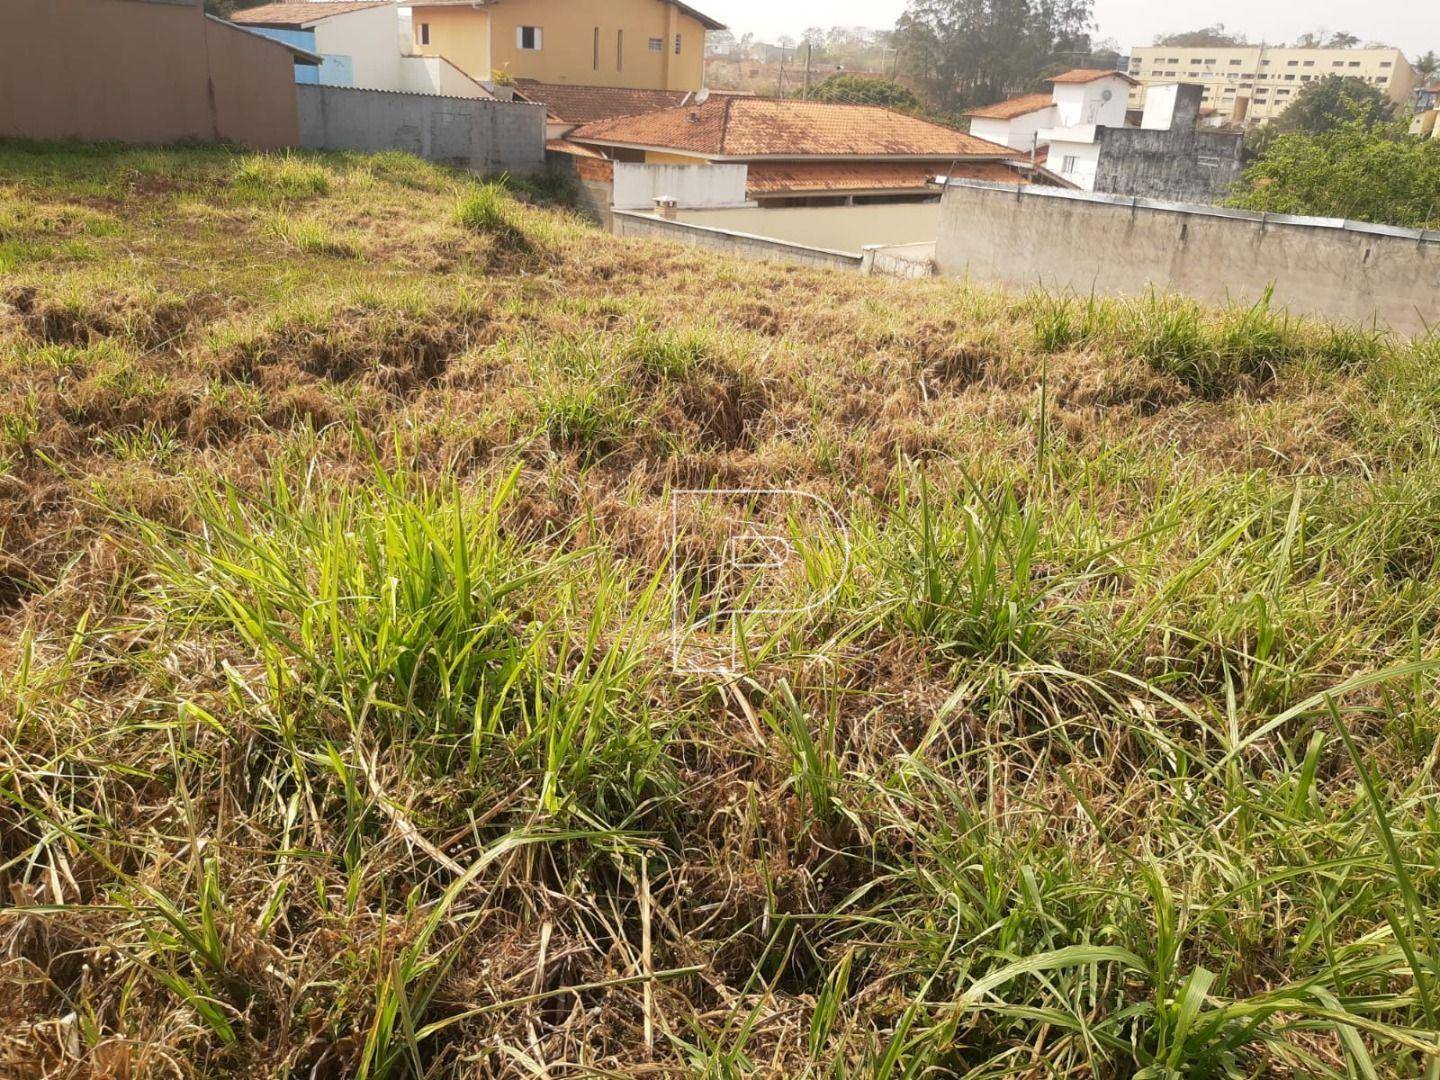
[0,144,1440,1077]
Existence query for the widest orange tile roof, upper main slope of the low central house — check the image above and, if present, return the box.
[569,98,1017,160]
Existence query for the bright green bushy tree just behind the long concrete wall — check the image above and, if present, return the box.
[1230,118,1440,229]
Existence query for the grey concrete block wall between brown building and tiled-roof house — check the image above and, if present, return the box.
[295,86,546,176]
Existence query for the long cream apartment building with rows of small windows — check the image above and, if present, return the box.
[1129,45,1417,124]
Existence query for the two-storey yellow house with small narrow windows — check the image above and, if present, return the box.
[412,0,724,91]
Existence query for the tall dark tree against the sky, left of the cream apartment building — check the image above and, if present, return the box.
[896,0,1094,112]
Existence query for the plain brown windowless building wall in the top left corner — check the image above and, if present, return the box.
[0,0,306,148]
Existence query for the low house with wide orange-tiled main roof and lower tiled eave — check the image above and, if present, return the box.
[552,95,1044,207]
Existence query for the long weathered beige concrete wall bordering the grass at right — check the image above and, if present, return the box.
[936,180,1440,334]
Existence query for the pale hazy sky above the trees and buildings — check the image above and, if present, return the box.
[702,0,1440,55]
